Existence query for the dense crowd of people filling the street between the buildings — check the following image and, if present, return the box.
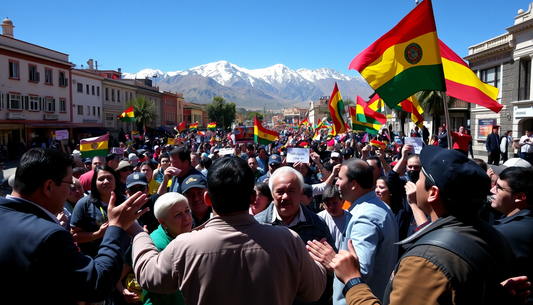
[0,122,533,304]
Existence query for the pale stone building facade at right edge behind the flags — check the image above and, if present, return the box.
[465,3,533,156]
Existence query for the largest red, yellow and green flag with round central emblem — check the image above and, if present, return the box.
[349,0,446,108]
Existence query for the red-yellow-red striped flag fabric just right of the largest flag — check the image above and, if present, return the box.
[439,40,503,113]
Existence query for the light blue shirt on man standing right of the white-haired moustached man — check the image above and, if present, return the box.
[333,191,398,305]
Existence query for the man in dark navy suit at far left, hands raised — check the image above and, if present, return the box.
[0,148,146,304]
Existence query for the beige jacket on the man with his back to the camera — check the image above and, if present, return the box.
[133,214,326,305]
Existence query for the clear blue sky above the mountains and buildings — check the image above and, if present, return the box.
[0,0,531,76]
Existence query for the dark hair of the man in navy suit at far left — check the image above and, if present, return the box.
[13,148,74,195]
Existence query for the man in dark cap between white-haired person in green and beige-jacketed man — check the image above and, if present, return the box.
[181,175,213,228]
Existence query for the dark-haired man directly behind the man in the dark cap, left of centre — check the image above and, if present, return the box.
[168,147,202,194]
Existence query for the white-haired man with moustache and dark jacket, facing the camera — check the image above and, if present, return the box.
[255,166,335,304]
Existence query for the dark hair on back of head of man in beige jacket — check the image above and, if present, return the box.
[207,156,254,214]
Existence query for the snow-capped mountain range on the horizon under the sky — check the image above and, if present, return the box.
[122,61,373,110]
